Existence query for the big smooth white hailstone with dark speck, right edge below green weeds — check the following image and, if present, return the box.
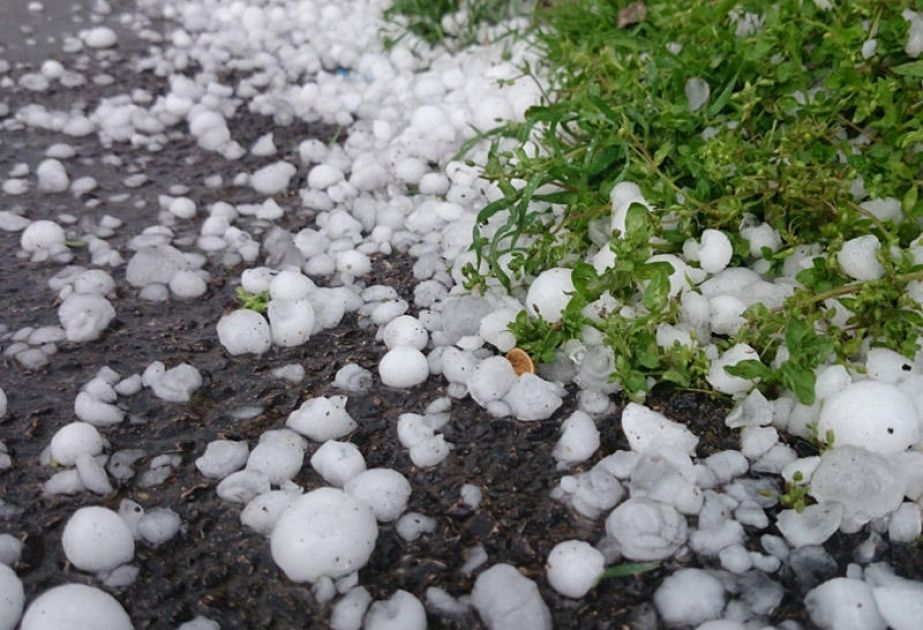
[817,381,920,454]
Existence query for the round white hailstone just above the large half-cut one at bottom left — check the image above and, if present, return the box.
[61,506,135,573]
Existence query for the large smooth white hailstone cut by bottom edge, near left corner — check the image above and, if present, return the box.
[20,584,134,630]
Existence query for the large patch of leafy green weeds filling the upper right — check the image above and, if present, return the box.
[465,0,923,404]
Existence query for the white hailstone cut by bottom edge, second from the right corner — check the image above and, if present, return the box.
[804,578,888,630]
